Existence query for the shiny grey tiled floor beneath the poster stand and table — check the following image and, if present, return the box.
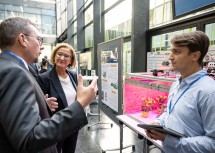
[75,104,160,153]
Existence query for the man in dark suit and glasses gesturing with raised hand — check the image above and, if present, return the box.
[0,18,97,153]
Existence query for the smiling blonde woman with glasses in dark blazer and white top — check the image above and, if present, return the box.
[37,43,78,153]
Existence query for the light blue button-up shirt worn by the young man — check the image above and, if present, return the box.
[158,70,215,153]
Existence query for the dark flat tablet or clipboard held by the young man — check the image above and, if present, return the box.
[137,124,186,138]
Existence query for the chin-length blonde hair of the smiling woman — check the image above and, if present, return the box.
[50,43,76,68]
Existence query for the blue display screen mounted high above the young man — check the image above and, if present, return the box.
[172,0,215,18]
